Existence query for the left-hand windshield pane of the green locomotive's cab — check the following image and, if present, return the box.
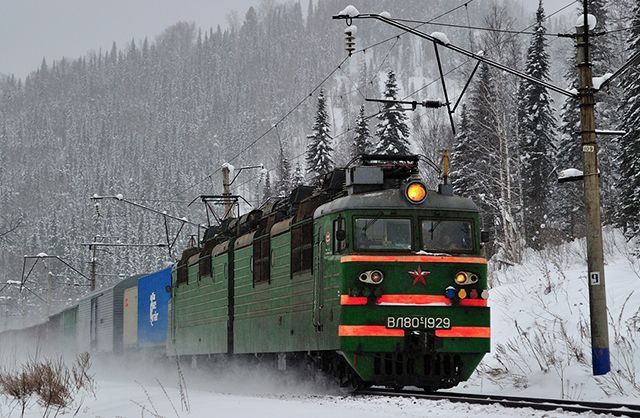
[355,218,411,250]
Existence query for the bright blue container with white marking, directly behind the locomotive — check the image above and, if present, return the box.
[138,267,171,347]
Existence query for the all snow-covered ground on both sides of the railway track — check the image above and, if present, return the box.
[0,231,640,418]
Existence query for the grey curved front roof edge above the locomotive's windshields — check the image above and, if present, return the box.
[313,188,478,218]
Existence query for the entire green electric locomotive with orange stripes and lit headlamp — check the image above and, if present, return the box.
[167,156,490,390]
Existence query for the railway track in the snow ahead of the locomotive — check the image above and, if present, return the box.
[354,388,640,418]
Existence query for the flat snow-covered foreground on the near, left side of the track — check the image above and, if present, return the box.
[0,364,616,418]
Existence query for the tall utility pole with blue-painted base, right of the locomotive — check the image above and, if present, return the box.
[577,4,611,376]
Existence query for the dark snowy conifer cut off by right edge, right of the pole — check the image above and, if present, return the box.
[618,0,640,237]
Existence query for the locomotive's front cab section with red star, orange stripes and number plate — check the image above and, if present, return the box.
[314,156,490,390]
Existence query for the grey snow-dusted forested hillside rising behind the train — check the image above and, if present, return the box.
[0,0,634,326]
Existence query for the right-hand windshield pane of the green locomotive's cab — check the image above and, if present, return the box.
[422,219,473,252]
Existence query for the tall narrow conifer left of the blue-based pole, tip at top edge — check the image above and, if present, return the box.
[518,0,555,248]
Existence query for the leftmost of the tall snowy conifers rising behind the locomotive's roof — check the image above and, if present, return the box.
[306,90,333,176]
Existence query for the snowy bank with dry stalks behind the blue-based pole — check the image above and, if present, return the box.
[456,230,640,403]
